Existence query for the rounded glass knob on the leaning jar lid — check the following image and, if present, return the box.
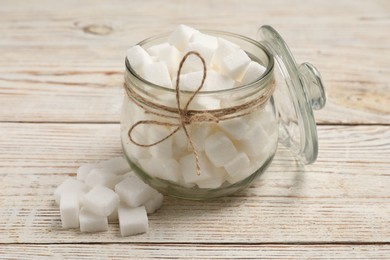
[298,62,326,110]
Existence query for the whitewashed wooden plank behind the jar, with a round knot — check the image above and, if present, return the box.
[0,0,390,124]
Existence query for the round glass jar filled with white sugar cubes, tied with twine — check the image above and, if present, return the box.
[121,25,326,199]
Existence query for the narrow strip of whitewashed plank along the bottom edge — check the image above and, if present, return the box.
[0,243,390,260]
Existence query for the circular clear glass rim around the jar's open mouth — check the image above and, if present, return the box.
[125,30,274,95]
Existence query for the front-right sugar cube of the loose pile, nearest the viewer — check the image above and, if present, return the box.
[118,205,149,237]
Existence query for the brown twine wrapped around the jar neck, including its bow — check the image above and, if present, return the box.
[125,51,275,175]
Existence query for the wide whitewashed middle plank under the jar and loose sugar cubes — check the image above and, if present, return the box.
[0,123,390,243]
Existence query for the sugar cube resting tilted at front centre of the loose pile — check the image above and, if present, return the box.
[83,186,119,217]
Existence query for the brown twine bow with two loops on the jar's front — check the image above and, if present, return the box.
[128,51,209,175]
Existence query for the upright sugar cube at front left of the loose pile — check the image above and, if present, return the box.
[60,193,79,228]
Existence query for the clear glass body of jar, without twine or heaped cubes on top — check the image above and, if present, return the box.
[121,32,278,200]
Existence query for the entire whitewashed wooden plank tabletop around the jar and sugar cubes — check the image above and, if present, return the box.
[0,0,390,259]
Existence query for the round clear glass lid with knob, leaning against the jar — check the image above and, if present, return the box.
[257,25,326,164]
